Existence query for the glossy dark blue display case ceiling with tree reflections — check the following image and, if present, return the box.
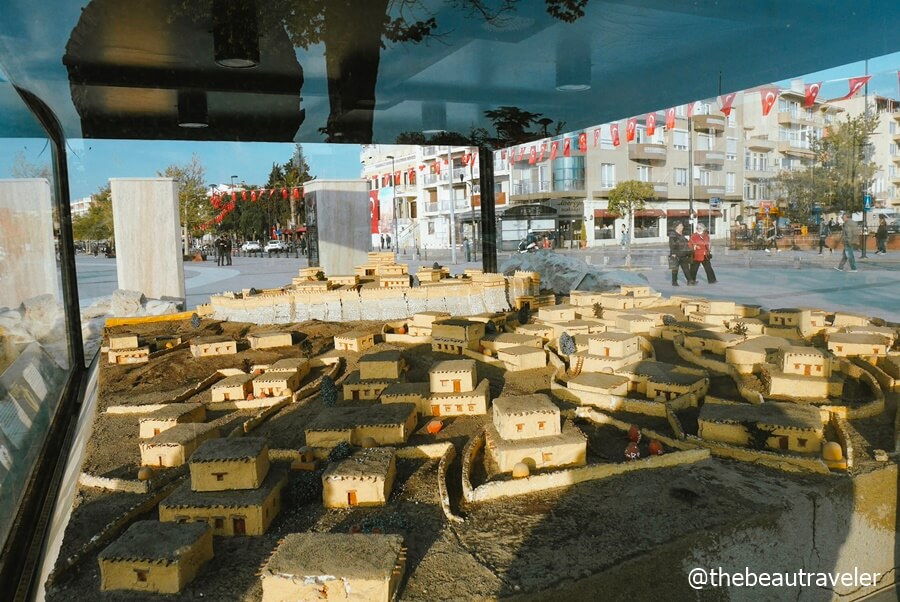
[0,0,900,143]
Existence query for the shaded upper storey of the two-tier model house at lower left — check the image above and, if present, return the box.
[190,437,269,491]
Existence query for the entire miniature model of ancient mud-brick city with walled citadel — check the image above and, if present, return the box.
[48,253,900,602]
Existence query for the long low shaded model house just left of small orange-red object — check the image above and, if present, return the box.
[305,403,416,447]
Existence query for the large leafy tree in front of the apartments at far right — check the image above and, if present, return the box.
[775,109,879,221]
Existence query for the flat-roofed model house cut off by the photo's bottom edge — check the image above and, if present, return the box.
[260,533,406,602]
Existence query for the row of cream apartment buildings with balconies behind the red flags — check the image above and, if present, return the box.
[362,80,900,248]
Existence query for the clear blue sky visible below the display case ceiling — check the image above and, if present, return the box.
[0,53,900,199]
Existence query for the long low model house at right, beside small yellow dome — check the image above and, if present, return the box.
[698,402,824,454]
